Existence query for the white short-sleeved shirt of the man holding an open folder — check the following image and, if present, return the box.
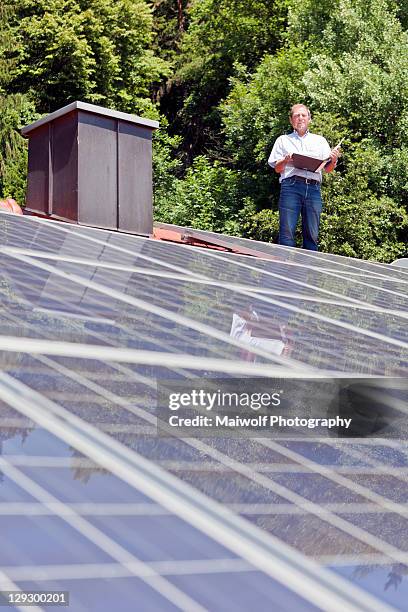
[268,131,331,182]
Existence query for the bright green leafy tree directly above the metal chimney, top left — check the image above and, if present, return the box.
[5,0,169,112]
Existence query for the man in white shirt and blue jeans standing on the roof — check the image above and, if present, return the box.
[268,104,340,251]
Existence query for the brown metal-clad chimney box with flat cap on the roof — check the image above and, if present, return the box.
[22,102,159,235]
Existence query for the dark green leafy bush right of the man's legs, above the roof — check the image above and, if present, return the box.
[321,141,408,262]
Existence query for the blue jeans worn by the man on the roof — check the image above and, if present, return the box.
[279,177,323,251]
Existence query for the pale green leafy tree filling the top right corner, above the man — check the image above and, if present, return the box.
[288,0,408,150]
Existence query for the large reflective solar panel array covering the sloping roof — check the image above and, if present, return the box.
[0,213,408,612]
